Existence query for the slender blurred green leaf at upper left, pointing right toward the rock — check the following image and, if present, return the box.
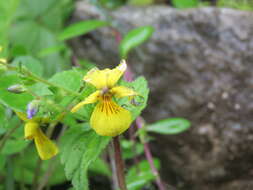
[59,20,108,40]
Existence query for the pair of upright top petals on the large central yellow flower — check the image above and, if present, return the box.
[83,60,127,89]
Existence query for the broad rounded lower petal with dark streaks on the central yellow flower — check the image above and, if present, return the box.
[90,100,132,136]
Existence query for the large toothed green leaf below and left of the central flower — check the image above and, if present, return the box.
[61,127,110,190]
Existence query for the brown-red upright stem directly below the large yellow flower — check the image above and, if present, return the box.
[113,136,127,190]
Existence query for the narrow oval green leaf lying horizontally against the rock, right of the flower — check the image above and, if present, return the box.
[146,118,191,135]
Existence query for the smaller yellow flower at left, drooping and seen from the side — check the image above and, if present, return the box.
[16,112,59,160]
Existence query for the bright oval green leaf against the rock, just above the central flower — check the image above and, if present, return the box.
[119,26,154,59]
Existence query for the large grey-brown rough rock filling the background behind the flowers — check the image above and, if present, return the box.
[70,2,253,190]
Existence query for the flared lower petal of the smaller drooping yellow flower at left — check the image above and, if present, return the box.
[34,128,59,160]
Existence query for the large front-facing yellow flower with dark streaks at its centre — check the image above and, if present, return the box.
[71,60,137,136]
